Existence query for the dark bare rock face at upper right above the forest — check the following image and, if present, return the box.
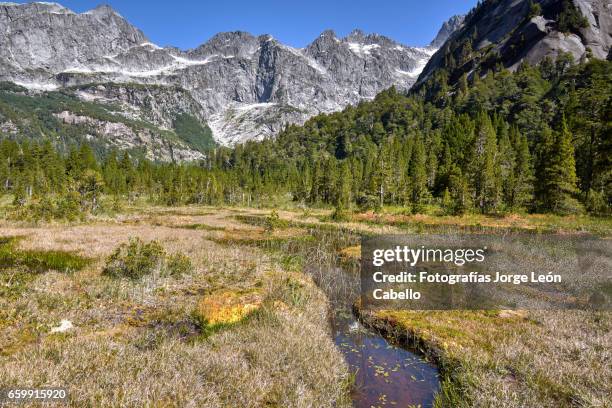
[419,0,612,85]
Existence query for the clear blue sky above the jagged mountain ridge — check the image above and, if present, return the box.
[20,0,476,49]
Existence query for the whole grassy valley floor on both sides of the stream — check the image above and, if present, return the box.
[0,207,612,407]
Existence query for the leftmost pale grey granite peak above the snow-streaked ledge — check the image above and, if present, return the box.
[0,3,146,85]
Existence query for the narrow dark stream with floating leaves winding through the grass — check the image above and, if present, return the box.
[310,267,440,408]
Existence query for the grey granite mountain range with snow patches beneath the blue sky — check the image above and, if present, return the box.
[0,3,460,145]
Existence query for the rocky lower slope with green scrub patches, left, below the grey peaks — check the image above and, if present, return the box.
[0,82,216,161]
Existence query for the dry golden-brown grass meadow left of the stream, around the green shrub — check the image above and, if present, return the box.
[0,208,350,407]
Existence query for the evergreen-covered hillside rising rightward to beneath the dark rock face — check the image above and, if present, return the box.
[224,56,612,217]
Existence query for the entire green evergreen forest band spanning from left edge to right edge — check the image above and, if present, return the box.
[0,56,612,220]
